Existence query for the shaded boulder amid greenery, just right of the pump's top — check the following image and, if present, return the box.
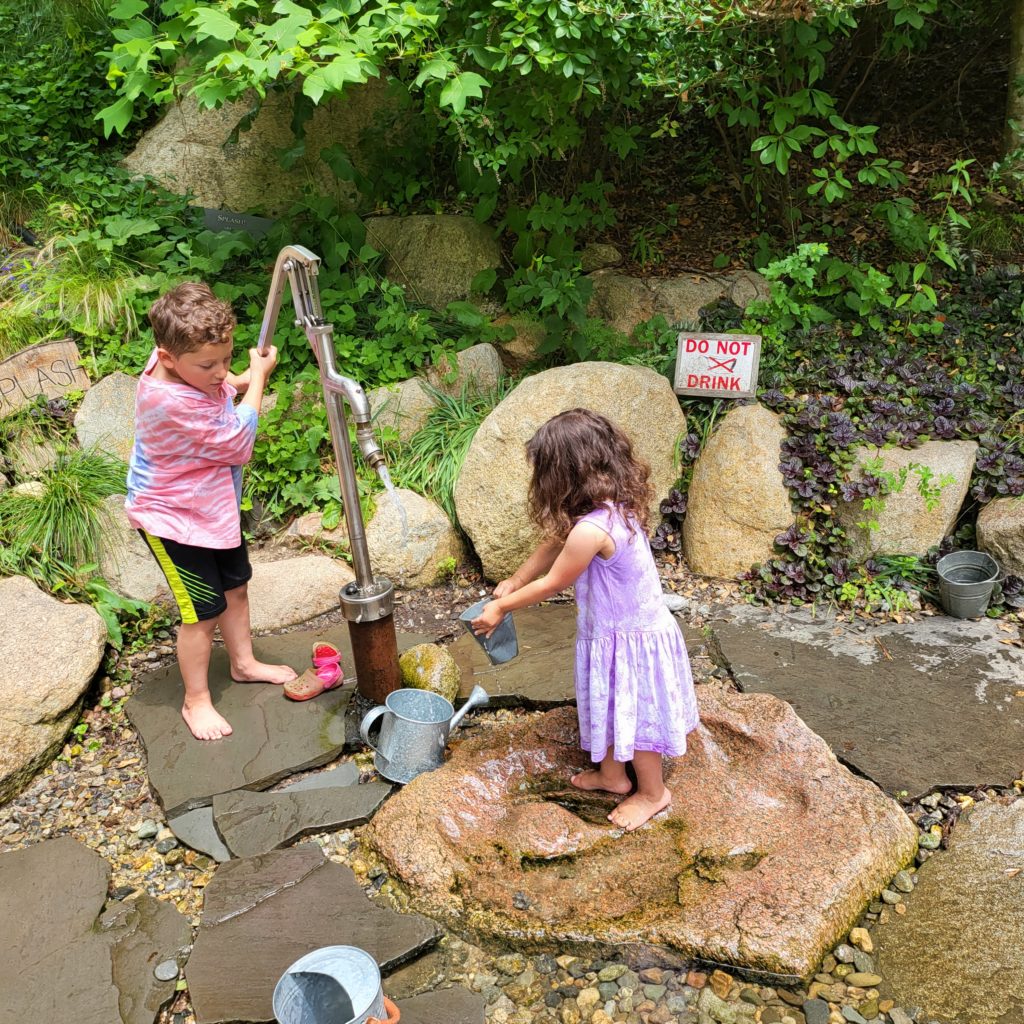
[366,214,502,309]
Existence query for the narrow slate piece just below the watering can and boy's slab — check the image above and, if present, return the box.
[213,773,392,857]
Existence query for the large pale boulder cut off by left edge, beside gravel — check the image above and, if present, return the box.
[0,577,106,801]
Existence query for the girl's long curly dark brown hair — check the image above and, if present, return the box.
[526,409,651,540]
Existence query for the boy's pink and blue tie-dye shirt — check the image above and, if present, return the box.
[125,350,259,550]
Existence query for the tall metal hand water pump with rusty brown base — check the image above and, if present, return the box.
[257,246,401,703]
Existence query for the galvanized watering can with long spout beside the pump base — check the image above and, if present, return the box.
[359,686,490,782]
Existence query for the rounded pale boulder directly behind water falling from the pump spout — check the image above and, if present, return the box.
[366,487,466,588]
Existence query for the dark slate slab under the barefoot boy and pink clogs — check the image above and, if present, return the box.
[125,629,427,817]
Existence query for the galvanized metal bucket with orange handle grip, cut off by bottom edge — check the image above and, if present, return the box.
[272,946,393,1024]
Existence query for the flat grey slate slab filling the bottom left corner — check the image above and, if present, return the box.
[0,838,191,1024]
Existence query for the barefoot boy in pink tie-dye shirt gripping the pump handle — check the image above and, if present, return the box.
[125,283,296,739]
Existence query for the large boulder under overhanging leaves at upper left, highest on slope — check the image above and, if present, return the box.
[119,82,387,216]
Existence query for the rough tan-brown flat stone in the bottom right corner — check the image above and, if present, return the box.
[871,800,1024,1024]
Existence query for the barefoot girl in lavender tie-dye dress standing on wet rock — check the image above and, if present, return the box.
[472,409,698,831]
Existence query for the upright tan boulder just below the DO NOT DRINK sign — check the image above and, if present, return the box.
[683,406,794,577]
